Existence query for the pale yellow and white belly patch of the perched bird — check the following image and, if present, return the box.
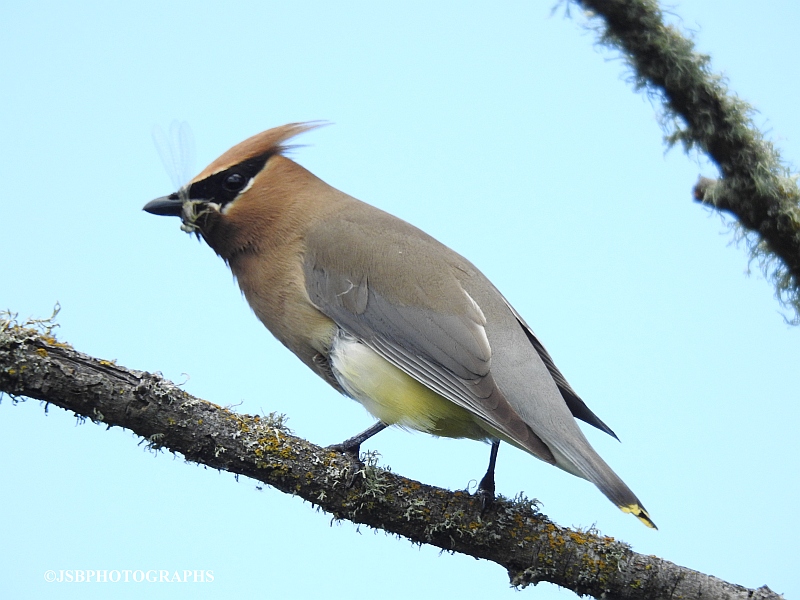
[330,336,489,440]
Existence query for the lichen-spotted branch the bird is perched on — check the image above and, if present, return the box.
[0,316,780,600]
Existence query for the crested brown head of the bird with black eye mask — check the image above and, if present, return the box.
[144,122,327,261]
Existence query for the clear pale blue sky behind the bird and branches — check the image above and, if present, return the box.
[0,0,800,599]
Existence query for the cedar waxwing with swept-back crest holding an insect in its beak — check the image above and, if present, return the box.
[144,123,655,527]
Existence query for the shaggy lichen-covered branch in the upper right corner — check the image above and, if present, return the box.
[574,0,800,324]
